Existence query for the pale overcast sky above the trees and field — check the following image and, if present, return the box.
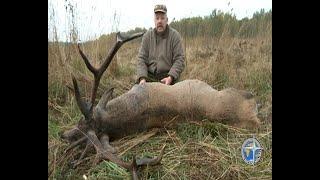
[48,0,272,41]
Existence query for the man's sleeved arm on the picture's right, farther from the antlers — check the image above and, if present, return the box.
[168,34,185,80]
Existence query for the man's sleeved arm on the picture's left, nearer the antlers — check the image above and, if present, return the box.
[137,32,150,83]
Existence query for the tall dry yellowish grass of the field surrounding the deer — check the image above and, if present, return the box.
[48,7,272,179]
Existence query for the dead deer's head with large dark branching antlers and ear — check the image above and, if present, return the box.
[62,32,164,179]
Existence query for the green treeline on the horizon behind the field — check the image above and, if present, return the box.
[127,9,272,38]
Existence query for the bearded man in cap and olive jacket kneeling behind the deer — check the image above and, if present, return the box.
[137,5,185,85]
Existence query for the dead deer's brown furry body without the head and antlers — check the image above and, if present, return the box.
[94,80,259,138]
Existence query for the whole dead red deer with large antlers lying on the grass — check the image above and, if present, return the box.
[63,33,260,179]
